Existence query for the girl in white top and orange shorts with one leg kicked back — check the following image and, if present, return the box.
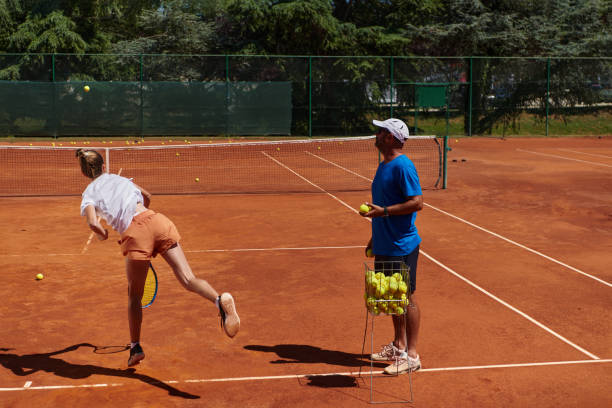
[76,149,240,366]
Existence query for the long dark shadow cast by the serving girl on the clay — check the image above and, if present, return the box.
[0,343,200,399]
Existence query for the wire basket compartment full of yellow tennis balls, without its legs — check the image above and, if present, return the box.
[364,261,410,316]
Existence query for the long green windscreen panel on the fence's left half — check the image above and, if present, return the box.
[0,81,292,136]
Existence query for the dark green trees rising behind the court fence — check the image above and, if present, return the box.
[0,0,612,133]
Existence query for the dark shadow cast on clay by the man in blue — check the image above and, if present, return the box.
[244,344,387,367]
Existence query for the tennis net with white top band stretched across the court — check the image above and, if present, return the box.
[0,136,442,196]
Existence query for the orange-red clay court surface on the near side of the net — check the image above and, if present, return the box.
[0,137,612,408]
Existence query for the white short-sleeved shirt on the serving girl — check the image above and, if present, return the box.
[81,173,144,234]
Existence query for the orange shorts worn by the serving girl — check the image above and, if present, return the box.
[119,210,181,261]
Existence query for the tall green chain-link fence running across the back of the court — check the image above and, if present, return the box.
[0,54,612,136]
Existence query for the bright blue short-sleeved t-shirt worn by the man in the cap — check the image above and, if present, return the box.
[372,155,423,256]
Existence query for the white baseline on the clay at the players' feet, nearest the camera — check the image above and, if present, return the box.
[0,359,612,391]
